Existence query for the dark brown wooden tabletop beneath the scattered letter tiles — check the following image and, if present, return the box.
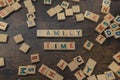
[0,0,120,80]
